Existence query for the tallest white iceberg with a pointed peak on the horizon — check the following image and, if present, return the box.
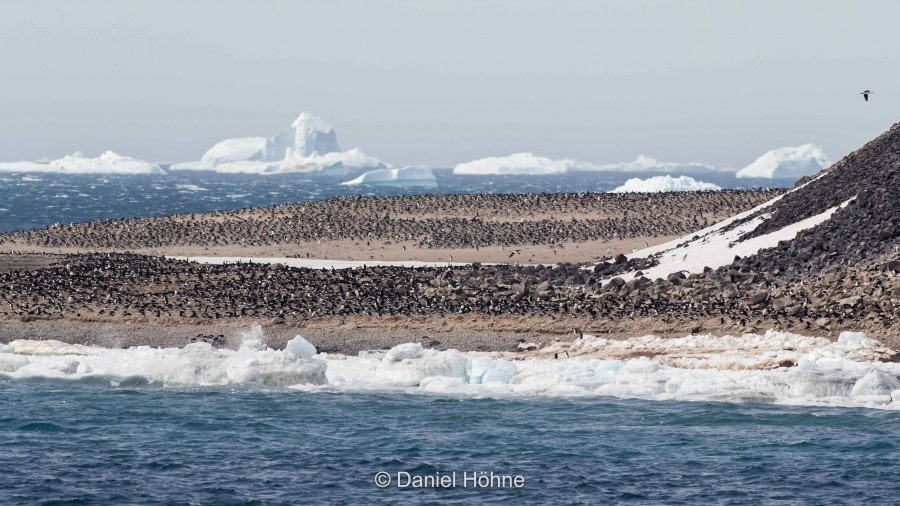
[171,111,388,174]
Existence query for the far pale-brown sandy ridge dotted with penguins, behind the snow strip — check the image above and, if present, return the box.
[0,190,781,263]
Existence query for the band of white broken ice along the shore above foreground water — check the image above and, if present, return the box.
[0,327,900,409]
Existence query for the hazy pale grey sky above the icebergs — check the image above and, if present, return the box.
[0,0,900,167]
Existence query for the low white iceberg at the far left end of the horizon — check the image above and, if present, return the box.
[0,151,166,174]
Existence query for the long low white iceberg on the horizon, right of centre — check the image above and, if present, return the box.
[453,153,719,176]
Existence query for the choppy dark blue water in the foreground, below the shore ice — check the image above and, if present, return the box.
[0,379,900,505]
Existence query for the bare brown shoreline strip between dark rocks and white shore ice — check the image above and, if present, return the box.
[0,315,900,355]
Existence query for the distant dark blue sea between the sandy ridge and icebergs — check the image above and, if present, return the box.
[0,169,794,233]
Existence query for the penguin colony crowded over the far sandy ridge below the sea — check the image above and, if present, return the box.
[0,190,783,251]
